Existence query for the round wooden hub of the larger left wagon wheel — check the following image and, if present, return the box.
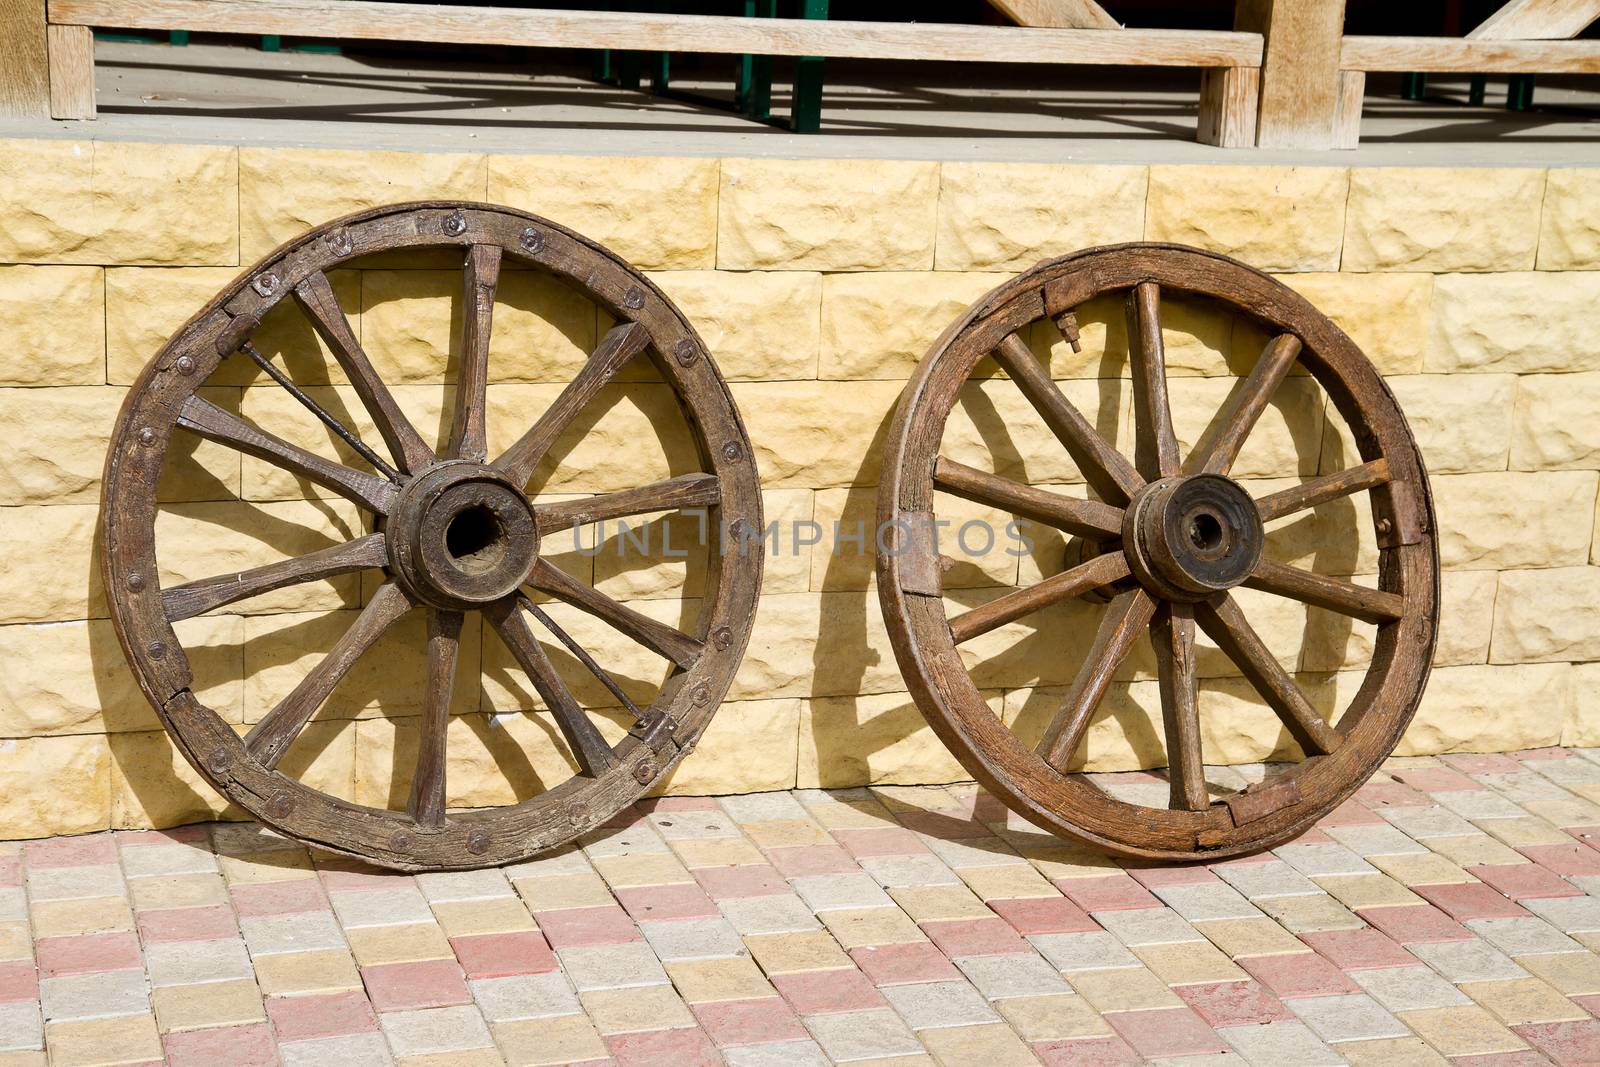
[386,461,539,609]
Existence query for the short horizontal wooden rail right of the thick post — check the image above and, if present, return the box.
[1339,37,1600,74]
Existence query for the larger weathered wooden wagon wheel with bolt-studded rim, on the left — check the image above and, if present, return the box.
[102,202,762,869]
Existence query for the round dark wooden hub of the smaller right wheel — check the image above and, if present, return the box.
[1123,474,1264,601]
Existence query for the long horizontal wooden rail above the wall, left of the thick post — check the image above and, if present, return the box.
[50,0,1261,67]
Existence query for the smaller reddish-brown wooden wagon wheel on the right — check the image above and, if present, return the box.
[878,245,1438,859]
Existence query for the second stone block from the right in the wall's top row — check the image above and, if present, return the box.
[1344,166,1544,274]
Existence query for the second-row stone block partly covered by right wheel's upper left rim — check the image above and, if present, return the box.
[818,270,1010,381]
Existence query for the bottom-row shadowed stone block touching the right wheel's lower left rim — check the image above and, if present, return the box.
[798,689,1003,789]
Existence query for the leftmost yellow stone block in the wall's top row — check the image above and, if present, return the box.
[0,139,238,266]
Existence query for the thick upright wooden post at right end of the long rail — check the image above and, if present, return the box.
[1234,0,1344,149]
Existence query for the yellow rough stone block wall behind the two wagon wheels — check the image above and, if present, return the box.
[0,141,1600,838]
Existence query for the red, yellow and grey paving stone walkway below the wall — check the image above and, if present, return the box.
[0,749,1600,1067]
